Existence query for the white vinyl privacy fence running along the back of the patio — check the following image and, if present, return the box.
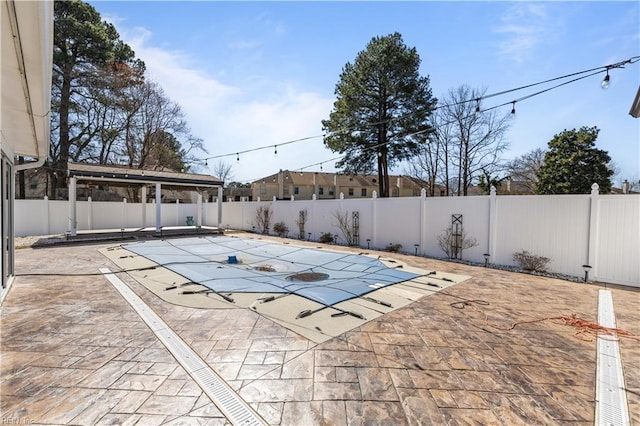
[15,190,640,287]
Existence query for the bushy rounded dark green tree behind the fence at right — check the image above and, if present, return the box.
[536,127,613,194]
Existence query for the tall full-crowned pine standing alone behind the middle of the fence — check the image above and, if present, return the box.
[322,33,437,197]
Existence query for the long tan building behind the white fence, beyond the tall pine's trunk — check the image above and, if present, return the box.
[251,170,426,201]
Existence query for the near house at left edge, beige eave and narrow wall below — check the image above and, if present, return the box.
[0,0,53,301]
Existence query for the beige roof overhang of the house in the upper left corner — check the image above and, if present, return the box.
[0,0,53,160]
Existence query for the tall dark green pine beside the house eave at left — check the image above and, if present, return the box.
[49,0,144,196]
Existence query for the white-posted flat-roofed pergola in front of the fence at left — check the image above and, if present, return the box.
[67,163,223,236]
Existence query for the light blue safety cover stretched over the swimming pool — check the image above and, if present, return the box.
[124,237,418,306]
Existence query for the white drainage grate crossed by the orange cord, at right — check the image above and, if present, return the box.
[595,289,630,426]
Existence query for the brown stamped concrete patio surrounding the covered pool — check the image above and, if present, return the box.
[0,238,640,425]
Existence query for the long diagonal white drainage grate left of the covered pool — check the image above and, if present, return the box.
[100,268,266,426]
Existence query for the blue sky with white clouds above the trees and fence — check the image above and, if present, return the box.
[90,1,640,183]
